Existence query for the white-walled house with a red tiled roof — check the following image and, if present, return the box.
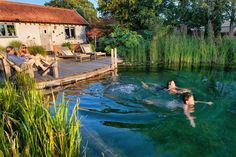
[0,1,88,51]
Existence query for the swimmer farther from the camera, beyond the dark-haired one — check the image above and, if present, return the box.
[141,80,190,94]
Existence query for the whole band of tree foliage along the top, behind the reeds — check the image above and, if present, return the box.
[98,0,236,36]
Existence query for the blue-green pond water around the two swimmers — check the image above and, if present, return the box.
[54,67,236,157]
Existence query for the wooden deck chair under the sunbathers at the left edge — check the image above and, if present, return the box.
[0,52,34,78]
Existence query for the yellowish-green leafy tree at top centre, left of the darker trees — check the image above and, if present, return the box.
[98,0,161,30]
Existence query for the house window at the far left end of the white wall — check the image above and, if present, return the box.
[0,23,16,37]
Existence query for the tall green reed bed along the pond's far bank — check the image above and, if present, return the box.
[123,34,236,67]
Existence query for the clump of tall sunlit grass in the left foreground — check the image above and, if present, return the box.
[0,76,80,157]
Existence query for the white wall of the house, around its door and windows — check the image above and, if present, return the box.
[0,23,86,47]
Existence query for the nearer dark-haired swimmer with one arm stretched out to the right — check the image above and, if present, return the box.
[183,93,213,127]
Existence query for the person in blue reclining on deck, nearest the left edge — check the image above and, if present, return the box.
[6,46,49,75]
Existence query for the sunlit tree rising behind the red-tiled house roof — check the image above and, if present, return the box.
[45,0,98,23]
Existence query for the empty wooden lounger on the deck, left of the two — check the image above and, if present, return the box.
[57,47,91,62]
